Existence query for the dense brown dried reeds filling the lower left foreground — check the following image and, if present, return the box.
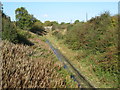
[2,42,66,88]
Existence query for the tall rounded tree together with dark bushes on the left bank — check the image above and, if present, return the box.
[0,7,46,45]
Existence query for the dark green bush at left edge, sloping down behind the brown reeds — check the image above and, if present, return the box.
[2,13,33,45]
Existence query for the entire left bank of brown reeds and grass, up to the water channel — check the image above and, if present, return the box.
[1,31,77,88]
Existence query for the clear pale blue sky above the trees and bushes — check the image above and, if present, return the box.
[2,2,118,23]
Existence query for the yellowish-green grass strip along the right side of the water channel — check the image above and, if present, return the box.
[46,32,118,88]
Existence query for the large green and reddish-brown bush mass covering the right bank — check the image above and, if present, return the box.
[65,12,118,74]
